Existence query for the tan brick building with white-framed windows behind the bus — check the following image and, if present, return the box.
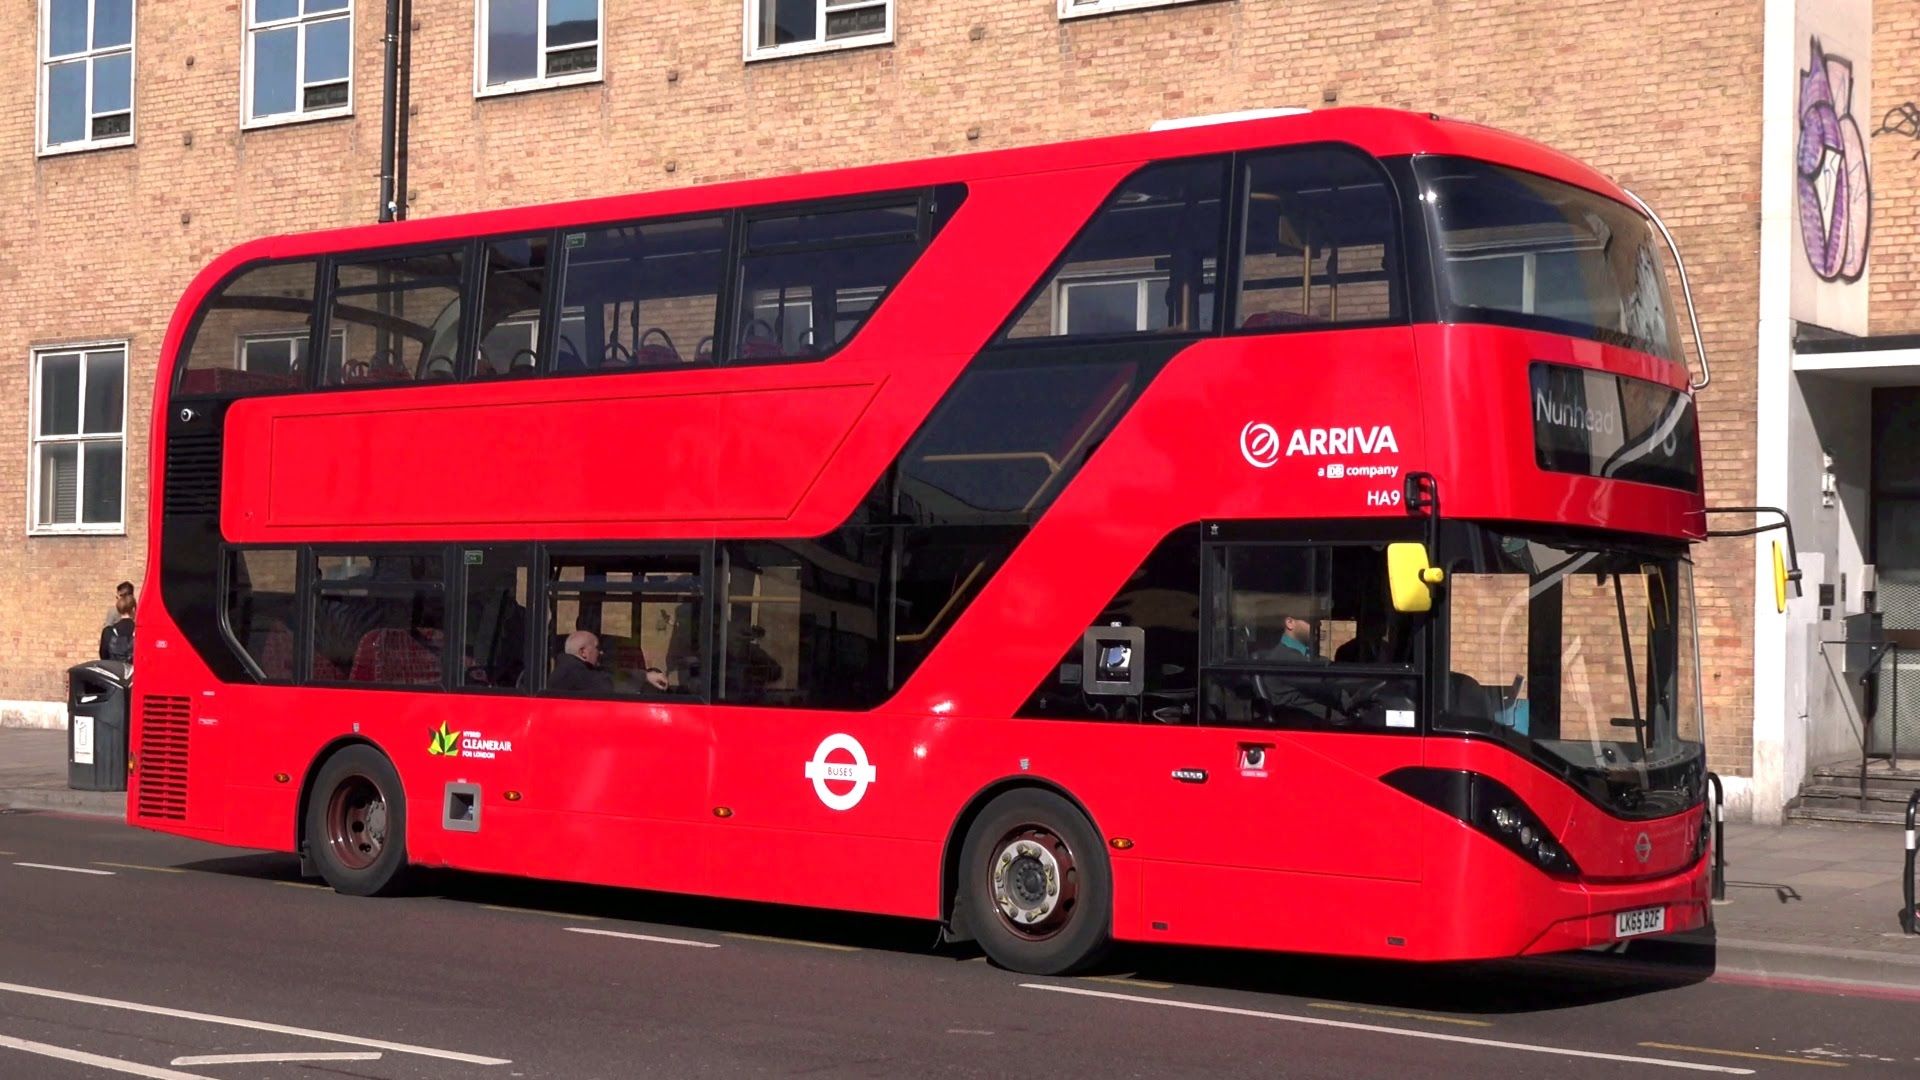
[0,0,1920,815]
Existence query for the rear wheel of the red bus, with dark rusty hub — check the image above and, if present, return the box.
[307,746,407,896]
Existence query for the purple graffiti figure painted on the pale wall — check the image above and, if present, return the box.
[1799,37,1874,284]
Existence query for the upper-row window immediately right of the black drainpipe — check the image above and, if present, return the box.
[474,0,607,94]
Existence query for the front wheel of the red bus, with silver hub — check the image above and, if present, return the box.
[958,788,1114,974]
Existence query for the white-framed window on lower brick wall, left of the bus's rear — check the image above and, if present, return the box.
[29,342,127,532]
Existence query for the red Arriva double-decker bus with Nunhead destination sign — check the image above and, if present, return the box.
[142,110,1709,972]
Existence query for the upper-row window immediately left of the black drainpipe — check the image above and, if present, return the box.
[242,0,353,125]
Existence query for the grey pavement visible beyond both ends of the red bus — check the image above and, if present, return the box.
[0,728,1920,988]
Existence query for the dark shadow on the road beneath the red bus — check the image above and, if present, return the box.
[180,855,1715,1015]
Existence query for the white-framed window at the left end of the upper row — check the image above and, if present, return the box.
[40,0,132,154]
